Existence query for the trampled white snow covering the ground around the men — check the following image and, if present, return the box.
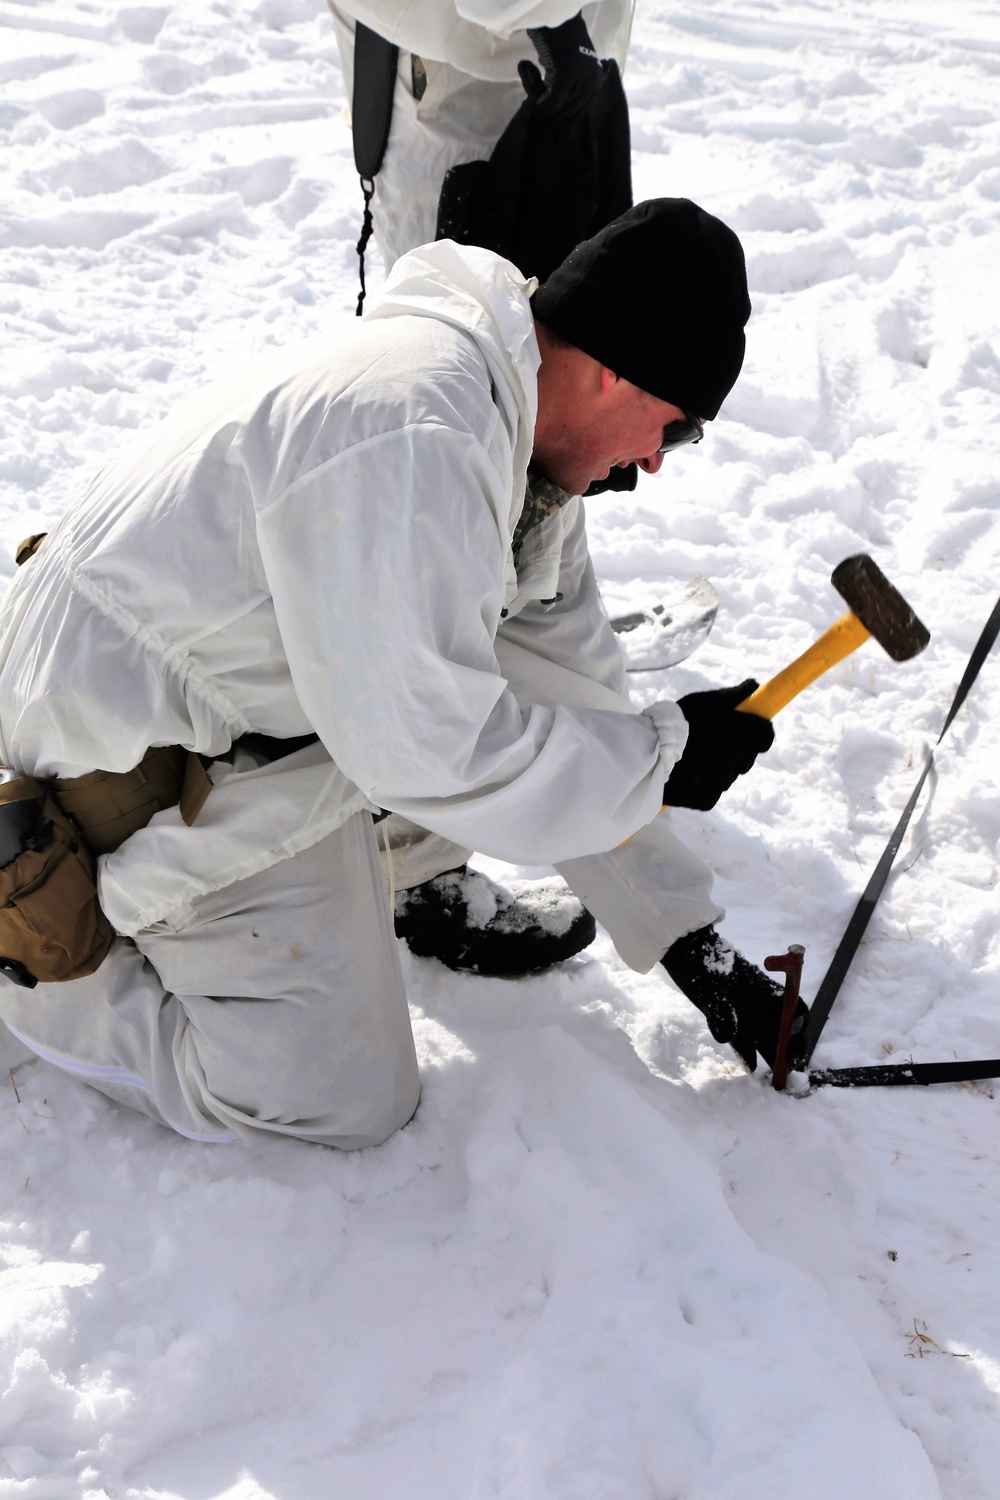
[0,0,1000,1500]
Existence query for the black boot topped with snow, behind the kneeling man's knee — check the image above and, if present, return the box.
[394,864,597,980]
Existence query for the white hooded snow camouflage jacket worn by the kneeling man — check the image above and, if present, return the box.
[0,242,687,932]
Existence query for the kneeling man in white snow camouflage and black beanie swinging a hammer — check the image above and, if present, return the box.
[0,200,797,1148]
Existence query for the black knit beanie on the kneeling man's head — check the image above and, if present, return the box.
[531,198,750,419]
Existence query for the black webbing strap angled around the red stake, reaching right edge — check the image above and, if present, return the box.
[792,600,1000,1086]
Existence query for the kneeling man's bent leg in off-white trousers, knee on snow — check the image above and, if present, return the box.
[0,813,420,1149]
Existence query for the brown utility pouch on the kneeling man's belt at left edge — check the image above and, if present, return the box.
[0,776,114,984]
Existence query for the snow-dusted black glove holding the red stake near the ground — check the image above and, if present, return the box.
[660,927,810,1073]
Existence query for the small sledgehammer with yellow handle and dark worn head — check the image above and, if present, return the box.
[739,552,931,719]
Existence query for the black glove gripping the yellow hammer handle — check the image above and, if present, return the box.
[663,677,774,813]
